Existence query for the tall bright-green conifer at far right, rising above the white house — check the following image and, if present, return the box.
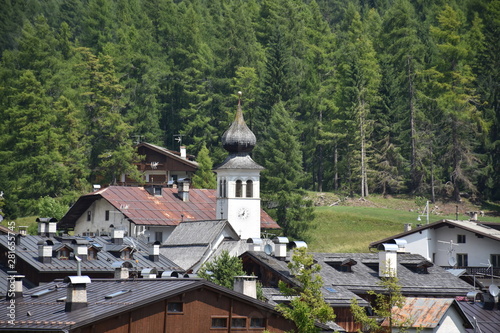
[428,5,482,201]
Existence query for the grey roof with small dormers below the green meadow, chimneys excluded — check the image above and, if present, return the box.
[246,252,472,297]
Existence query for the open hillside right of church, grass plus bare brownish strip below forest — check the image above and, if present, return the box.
[309,193,500,252]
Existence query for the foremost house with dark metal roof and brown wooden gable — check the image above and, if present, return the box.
[0,276,331,333]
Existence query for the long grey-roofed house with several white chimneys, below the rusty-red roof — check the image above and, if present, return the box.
[0,222,184,286]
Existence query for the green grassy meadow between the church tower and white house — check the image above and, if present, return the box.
[308,192,500,253]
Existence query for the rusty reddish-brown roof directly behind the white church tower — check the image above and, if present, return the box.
[58,186,279,229]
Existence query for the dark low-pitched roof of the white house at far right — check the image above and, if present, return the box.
[369,220,500,248]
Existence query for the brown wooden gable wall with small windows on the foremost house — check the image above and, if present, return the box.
[79,288,294,333]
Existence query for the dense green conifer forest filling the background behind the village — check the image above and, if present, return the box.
[0,0,500,220]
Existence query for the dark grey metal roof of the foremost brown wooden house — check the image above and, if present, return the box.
[0,279,292,331]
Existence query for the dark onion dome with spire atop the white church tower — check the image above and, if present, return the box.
[222,91,257,153]
